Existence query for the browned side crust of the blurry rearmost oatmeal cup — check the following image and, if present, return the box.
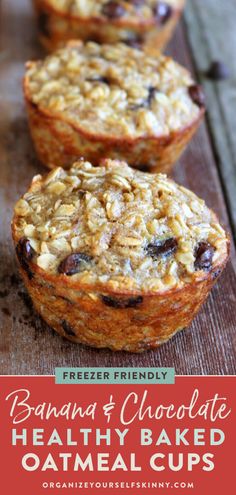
[34,0,185,52]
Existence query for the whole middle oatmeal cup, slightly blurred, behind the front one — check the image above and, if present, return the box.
[24,41,205,172]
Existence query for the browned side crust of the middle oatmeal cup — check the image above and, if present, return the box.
[24,77,205,173]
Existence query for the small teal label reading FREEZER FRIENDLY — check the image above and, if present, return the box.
[55,368,175,385]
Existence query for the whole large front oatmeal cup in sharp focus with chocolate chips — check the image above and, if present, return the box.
[12,159,229,352]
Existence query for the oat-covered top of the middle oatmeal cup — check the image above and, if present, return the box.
[26,42,203,138]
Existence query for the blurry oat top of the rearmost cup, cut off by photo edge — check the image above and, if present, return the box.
[42,0,184,23]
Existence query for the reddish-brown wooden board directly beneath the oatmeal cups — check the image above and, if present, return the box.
[0,0,236,375]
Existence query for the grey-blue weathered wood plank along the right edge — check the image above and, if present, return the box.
[185,0,236,241]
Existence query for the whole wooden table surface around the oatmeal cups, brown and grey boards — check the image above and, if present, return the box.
[0,0,236,375]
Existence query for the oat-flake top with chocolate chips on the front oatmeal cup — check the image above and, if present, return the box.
[14,160,228,294]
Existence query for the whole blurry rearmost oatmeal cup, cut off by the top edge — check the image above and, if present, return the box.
[34,0,185,50]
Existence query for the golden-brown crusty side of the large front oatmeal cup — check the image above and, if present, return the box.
[12,254,229,352]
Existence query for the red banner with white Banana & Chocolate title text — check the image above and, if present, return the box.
[0,376,235,495]
